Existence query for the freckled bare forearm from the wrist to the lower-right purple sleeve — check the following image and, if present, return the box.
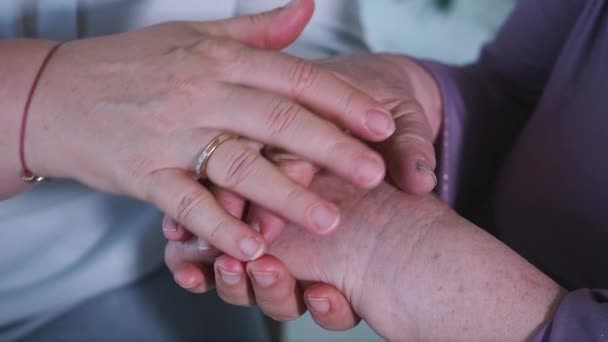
[362,211,564,340]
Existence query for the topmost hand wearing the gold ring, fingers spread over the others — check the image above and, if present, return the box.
[26,1,394,260]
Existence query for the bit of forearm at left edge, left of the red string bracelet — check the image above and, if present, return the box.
[0,39,54,200]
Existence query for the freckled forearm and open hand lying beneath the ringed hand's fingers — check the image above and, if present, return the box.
[168,172,563,341]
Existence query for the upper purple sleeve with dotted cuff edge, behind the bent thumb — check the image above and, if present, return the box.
[422,0,586,216]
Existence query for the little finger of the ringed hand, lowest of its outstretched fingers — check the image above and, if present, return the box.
[144,169,266,261]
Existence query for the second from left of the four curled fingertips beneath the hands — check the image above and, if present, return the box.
[214,255,255,306]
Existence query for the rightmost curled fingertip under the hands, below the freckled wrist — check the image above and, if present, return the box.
[304,283,361,330]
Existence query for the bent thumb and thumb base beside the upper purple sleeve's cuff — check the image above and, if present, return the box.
[321,53,442,194]
